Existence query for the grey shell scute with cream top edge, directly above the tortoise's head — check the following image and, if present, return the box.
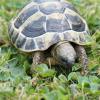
[46,13,71,32]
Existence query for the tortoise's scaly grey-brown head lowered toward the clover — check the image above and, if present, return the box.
[52,42,76,67]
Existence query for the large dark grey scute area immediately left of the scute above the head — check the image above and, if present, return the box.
[22,16,46,38]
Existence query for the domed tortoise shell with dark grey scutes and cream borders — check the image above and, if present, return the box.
[9,0,90,52]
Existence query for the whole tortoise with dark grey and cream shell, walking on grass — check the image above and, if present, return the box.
[9,0,91,73]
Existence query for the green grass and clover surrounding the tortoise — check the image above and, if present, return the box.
[0,0,100,100]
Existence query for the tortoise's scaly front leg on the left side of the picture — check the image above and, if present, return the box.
[31,51,45,73]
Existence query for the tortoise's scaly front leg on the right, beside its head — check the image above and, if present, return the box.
[75,45,88,75]
